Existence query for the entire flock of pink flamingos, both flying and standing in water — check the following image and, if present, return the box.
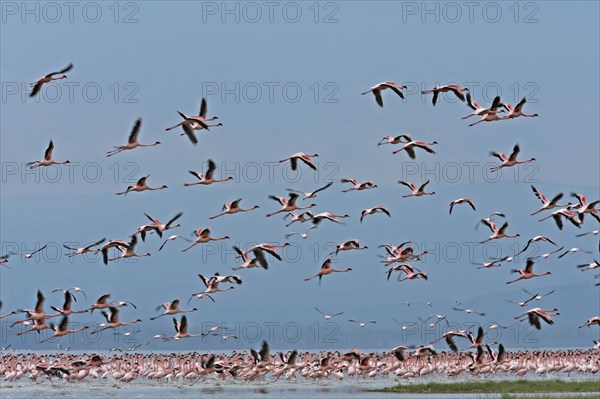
[0,64,600,384]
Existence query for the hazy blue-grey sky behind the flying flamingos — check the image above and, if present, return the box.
[0,1,600,349]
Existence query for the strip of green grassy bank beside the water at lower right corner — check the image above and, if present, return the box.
[376,380,600,397]
